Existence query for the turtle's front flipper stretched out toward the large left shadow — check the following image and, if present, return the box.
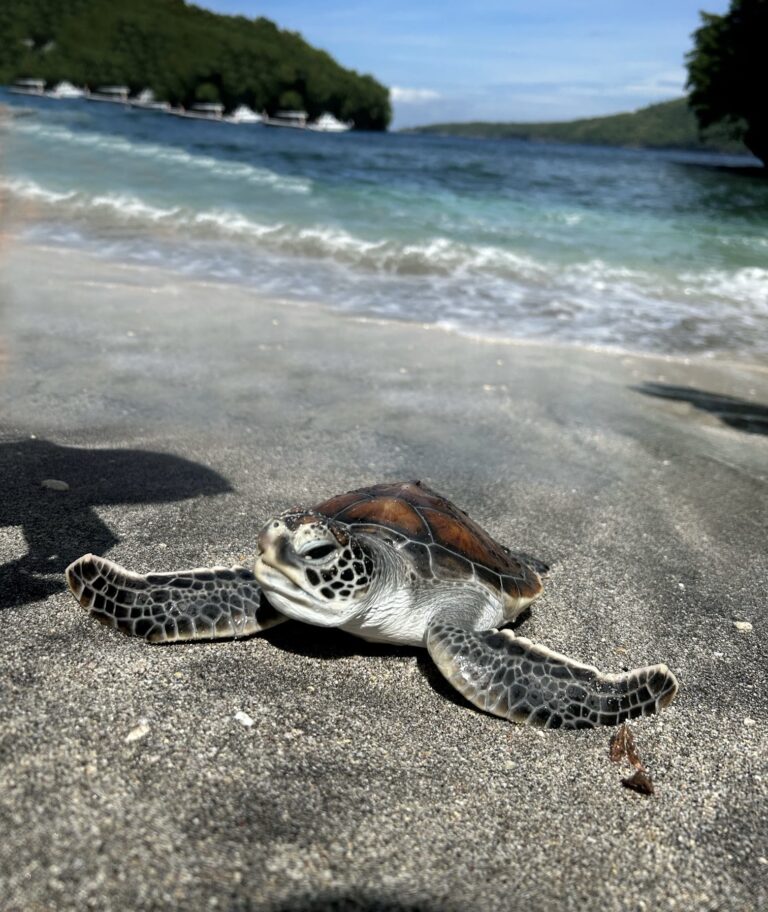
[66,554,286,643]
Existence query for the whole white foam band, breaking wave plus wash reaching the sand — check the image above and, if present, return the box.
[6,164,768,350]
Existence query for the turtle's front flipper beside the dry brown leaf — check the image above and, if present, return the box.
[427,623,677,728]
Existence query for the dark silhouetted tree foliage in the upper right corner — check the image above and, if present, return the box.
[686,0,768,166]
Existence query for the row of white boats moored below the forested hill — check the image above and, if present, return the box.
[10,79,354,133]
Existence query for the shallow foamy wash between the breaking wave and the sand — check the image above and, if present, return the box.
[16,222,766,357]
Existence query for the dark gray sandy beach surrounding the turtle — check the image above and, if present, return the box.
[0,246,768,912]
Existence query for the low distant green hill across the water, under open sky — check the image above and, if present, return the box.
[409,98,749,154]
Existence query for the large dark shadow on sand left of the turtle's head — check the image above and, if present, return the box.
[0,440,232,610]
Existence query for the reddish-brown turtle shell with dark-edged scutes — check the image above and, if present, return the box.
[313,481,543,607]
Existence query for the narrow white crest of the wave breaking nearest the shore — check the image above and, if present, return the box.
[0,179,768,310]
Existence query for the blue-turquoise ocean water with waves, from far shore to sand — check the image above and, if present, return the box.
[0,93,768,360]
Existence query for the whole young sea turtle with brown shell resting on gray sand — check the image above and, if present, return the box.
[66,481,677,728]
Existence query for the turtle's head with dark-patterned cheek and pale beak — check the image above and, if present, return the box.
[254,512,375,627]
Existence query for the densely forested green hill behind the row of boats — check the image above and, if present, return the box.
[0,0,391,130]
